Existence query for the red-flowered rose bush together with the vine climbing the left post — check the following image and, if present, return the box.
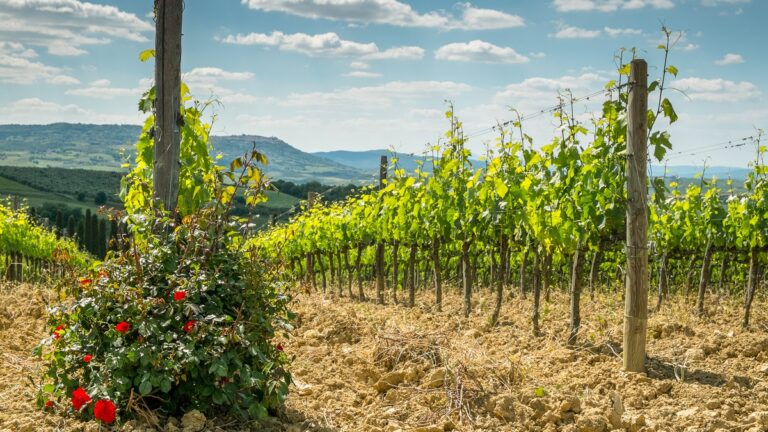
[36,84,292,424]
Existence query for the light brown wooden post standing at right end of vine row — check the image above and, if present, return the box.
[624,59,649,372]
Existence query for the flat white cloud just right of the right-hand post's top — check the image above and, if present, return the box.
[672,77,760,102]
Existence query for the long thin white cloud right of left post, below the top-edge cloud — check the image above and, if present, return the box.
[221,31,424,59]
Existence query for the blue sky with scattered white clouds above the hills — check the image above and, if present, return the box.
[0,0,768,166]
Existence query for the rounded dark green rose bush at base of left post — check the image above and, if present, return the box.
[38,205,291,418]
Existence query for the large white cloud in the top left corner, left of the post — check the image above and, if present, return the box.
[0,0,154,56]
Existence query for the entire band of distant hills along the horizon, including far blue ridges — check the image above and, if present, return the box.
[0,123,750,184]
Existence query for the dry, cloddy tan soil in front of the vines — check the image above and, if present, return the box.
[0,286,768,432]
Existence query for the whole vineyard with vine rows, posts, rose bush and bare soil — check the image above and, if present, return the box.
[0,5,768,432]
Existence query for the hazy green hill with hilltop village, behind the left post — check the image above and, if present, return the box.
[0,123,373,184]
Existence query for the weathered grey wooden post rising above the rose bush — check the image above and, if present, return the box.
[152,0,184,212]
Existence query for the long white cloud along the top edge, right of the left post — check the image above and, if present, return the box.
[242,0,525,30]
